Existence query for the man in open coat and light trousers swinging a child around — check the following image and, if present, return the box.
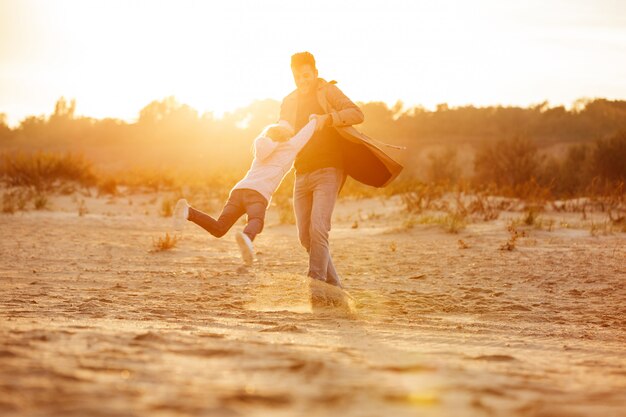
[279,52,402,287]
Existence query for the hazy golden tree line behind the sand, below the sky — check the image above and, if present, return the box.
[0,97,626,194]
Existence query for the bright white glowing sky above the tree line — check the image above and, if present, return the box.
[0,0,626,124]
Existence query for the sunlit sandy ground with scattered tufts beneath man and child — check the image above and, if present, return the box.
[0,190,626,417]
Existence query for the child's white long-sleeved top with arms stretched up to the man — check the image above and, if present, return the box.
[233,120,317,204]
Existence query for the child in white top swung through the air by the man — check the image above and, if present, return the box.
[174,117,317,265]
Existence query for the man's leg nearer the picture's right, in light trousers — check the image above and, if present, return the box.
[309,168,343,281]
